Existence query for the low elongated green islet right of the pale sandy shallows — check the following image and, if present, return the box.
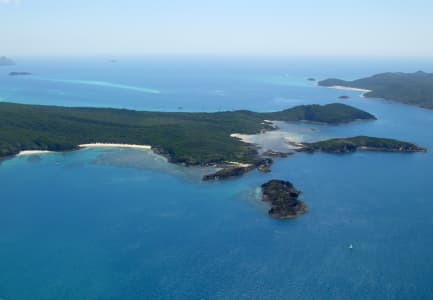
[299,136,426,153]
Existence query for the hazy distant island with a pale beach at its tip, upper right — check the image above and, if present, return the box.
[318,71,433,109]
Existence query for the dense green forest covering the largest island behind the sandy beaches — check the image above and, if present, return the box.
[0,103,374,165]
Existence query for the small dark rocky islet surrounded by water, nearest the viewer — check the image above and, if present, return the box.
[261,179,307,219]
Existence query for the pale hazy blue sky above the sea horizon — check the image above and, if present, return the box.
[0,0,433,56]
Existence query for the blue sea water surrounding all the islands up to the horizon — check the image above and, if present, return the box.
[0,58,433,300]
